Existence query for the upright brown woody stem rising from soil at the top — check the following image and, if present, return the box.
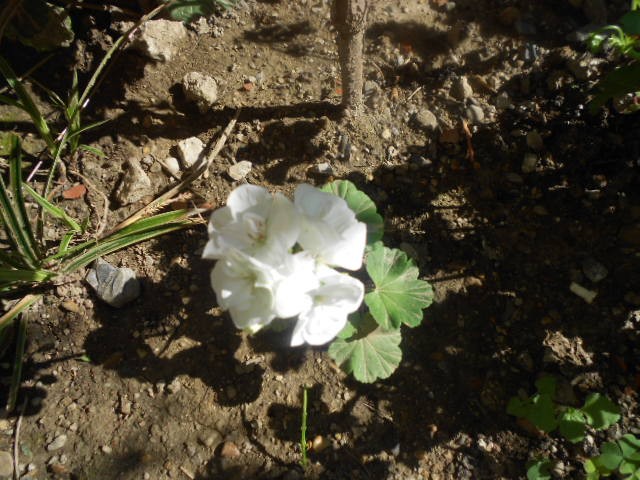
[331,0,369,114]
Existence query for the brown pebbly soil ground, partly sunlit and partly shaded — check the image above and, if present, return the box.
[0,0,640,480]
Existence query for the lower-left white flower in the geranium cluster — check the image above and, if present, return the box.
[211,249,281,332]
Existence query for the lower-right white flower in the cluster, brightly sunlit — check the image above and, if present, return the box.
[291,264,364,347]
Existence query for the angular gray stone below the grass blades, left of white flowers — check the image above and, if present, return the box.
[86,258,140,308]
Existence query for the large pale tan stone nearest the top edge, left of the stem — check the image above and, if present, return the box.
[132,19,187,62]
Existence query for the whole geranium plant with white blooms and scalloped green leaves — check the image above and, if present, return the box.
[203,180,433,383]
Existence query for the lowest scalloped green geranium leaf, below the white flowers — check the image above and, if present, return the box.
[329,315,402,383]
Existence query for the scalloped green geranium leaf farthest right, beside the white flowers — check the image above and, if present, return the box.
[364,242,433,329]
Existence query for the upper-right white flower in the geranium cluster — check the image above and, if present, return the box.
[294,184,367,270]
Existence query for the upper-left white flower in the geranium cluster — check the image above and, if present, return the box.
[202,184,300,265]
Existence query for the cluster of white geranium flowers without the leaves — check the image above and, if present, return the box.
[202,184,367,346]
